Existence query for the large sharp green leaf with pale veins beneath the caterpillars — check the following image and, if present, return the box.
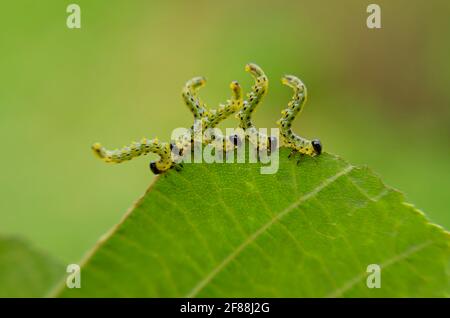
[54,149,450,297]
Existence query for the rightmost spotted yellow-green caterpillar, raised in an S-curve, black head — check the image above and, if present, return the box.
[277,75,322,156]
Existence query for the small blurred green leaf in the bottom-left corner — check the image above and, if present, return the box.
[0,236,65,298]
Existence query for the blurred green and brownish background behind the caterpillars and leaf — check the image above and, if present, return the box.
[0,0,450,262]
